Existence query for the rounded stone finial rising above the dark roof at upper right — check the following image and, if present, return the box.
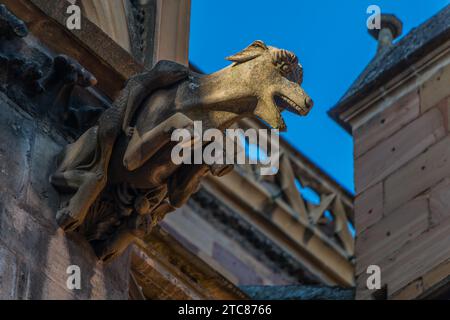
[369,14,403,54]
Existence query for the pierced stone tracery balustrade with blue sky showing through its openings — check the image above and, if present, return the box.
[237,119,354,260]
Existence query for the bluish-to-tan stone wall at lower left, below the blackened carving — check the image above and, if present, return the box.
[0,92,129,299]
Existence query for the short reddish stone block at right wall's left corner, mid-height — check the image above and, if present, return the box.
[355,183,383,235]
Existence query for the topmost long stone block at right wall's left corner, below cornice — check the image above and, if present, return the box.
[353,90,420,158]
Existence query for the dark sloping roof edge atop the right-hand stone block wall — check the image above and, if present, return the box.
[328,5,450,131]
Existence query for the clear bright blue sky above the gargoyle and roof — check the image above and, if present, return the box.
[189,0,450,191]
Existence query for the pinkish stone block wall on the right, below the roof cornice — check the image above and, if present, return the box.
[353,59,450,299]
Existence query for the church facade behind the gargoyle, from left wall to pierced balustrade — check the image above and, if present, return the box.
[0,0,355,299]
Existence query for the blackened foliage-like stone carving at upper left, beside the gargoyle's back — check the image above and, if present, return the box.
[0,5,106,136]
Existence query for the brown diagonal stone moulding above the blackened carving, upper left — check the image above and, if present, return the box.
[2,0,144,98]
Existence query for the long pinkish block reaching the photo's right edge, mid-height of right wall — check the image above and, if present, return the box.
[384,137,450,213]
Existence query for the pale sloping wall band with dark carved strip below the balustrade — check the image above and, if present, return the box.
[160,189,320,286]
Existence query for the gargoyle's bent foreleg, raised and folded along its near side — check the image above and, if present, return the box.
[123,113,194,171]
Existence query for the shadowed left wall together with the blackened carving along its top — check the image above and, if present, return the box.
[0,5,129,299]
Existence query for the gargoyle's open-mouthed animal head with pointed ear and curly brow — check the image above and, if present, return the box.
[227,40,313,131]
